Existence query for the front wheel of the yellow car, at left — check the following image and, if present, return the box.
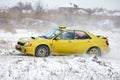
[35,45,50,57]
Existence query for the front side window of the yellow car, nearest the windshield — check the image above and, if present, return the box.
[60,31,74,40]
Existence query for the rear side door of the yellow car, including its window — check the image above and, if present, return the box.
[74,30,92,53]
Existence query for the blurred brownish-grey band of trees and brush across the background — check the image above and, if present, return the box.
[0,0,120,26]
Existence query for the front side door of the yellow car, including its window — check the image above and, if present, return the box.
[52,30,75,54]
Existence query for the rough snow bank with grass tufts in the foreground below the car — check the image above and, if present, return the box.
[0,56,120,80]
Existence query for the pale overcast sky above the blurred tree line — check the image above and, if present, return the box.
[0,0,120,10]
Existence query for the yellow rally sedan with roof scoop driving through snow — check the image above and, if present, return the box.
[15,26,110,57]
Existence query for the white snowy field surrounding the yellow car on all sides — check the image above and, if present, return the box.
[0,25,120,80]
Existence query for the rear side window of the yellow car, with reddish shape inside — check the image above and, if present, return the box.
[75,31,91,39]
